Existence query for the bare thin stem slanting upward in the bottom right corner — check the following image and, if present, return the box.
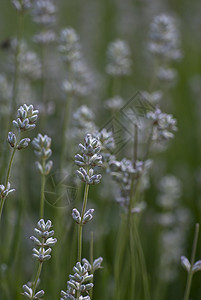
[183,223,200,300]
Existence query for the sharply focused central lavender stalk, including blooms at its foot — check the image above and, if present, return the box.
[61,134,102,300]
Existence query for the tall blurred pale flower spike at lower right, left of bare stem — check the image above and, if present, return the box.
[156,175,190,282]
